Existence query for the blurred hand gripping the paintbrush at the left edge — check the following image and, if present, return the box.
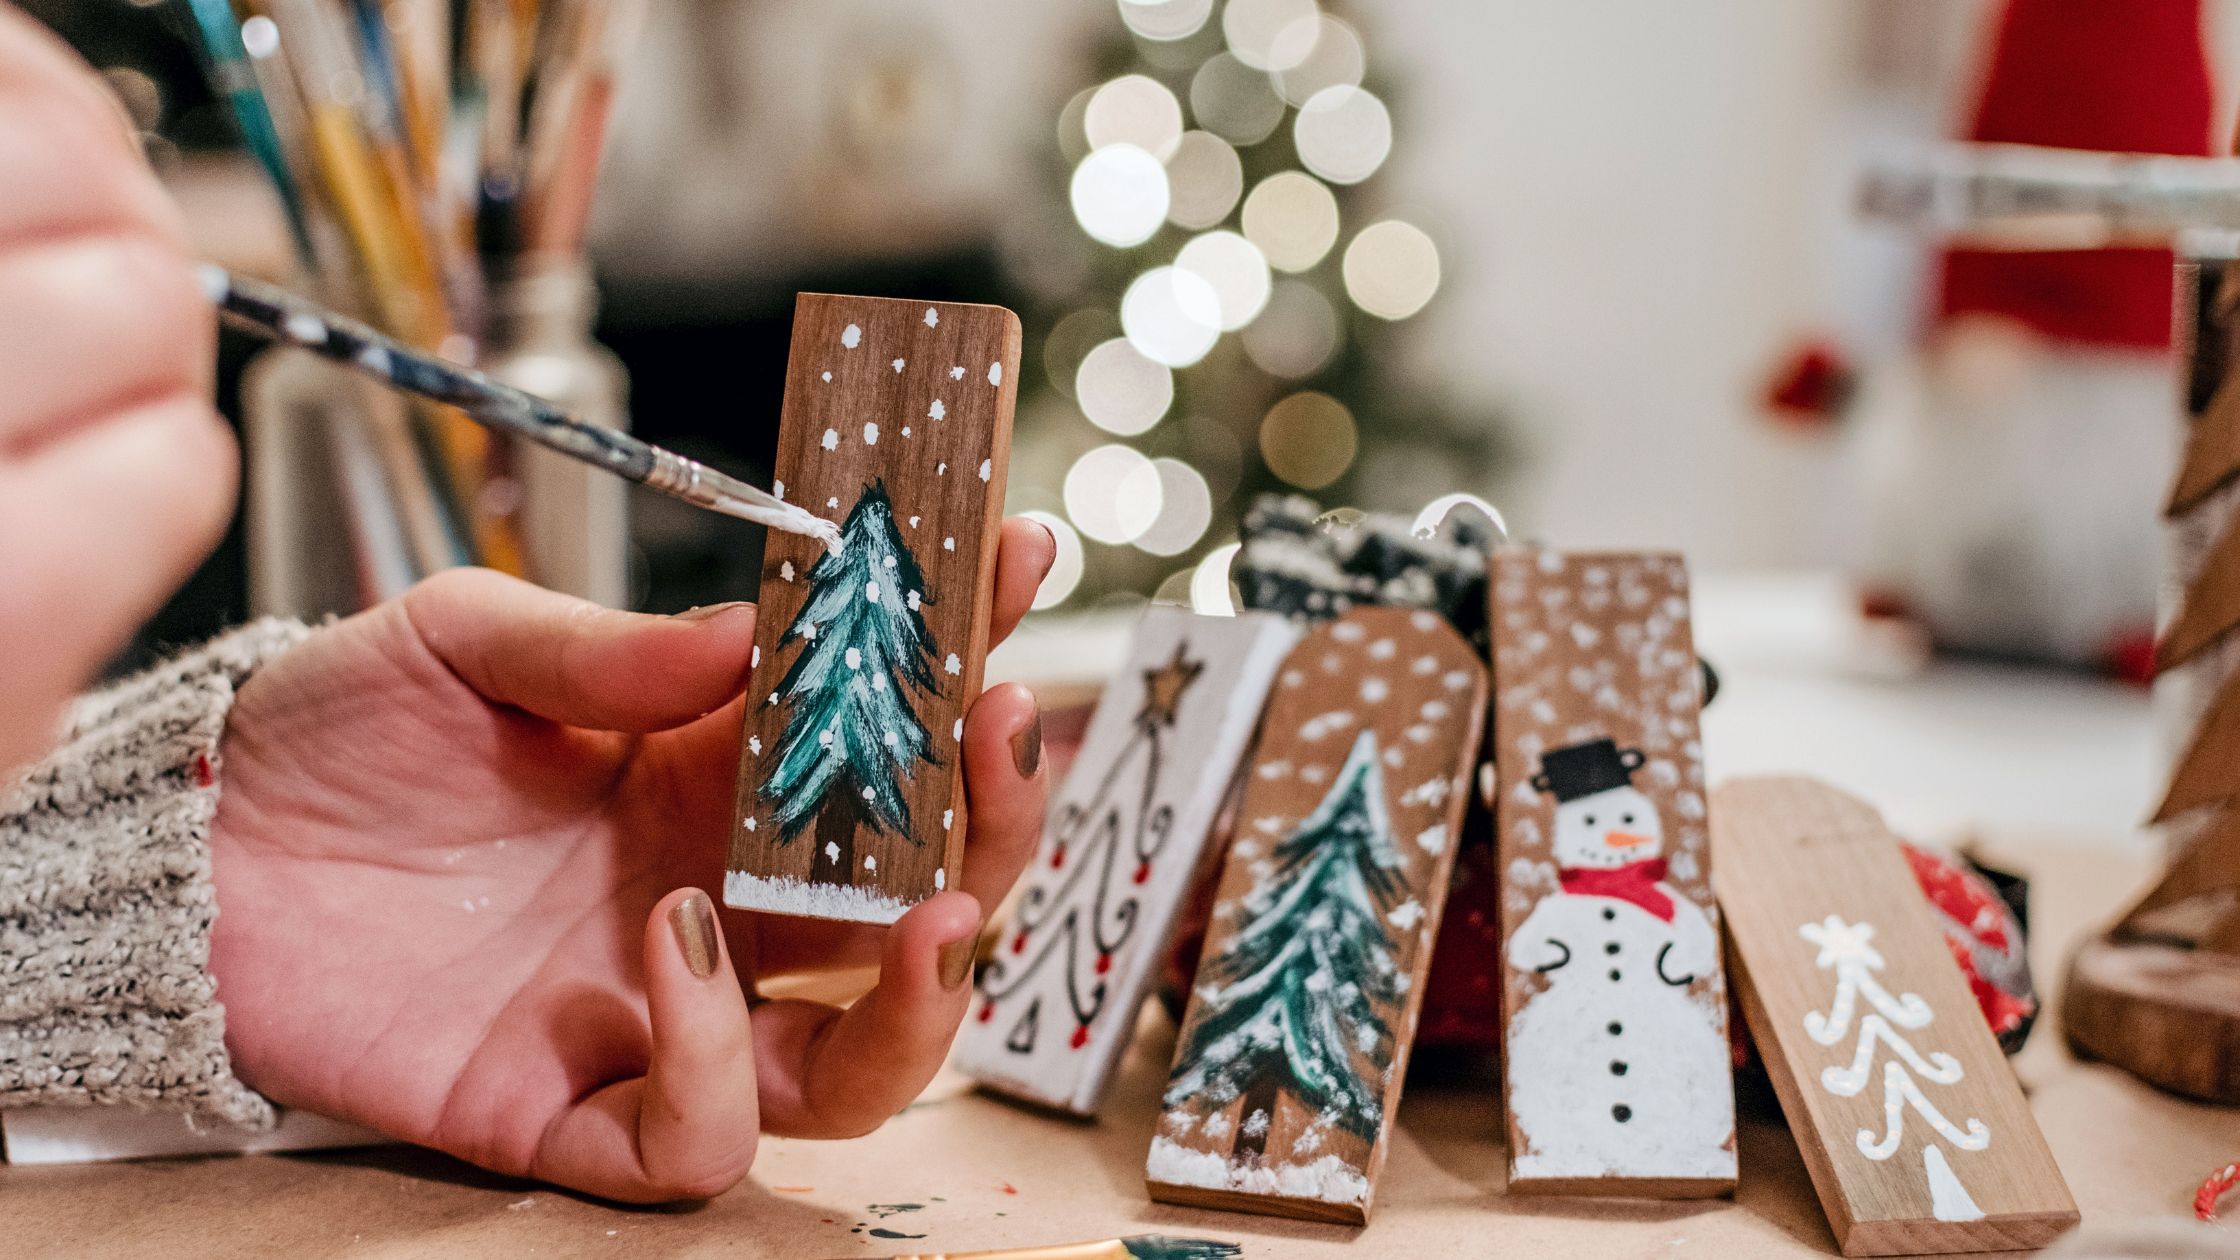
[0,4,237,773]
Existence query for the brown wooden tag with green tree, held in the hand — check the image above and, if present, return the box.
[724,294,1019,924]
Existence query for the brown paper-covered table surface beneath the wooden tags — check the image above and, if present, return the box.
[0,845,2240,1260]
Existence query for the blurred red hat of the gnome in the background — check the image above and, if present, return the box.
[1938,0,2213,350]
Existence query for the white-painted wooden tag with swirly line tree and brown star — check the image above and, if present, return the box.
[952,608,1299,1114]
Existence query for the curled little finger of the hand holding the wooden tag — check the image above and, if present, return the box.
[531,888,762,1204]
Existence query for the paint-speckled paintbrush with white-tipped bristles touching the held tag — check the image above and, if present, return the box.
[199,265,840,552]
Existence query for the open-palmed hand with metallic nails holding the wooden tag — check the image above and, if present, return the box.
[211,520,1055,1202]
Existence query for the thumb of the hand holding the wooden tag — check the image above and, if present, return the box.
[403,569,755,731]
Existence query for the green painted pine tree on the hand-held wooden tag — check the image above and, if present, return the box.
[762,482,939,883]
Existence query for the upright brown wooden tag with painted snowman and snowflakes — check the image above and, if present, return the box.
[1487,547,1734,1197]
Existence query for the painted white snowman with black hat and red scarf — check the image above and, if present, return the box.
[1505,740,1734,1177]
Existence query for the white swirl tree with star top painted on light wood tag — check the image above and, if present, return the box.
[1796,915,1991,1220]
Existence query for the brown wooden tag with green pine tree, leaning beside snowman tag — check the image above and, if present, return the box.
[1147,608,1485,1224]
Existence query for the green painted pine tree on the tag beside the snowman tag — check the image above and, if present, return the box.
[1167,731,1407,1155]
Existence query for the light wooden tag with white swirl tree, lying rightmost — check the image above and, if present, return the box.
[1711,778,2076,1256]
